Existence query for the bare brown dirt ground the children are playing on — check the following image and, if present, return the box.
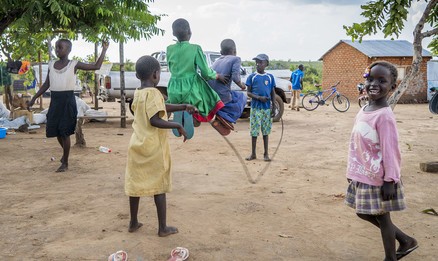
[0,98,438,261]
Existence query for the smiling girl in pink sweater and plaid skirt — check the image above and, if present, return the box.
[345,61,418,260]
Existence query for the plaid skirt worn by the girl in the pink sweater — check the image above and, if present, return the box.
[345,180,406,215]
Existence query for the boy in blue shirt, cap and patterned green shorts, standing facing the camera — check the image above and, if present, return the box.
[246,54,276,161]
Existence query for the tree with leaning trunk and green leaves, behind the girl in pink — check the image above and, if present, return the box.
[344,0,438,109]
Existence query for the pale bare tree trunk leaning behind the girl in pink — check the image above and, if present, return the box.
[388,0,438,110]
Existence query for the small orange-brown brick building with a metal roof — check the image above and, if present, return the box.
[319,40,432,103]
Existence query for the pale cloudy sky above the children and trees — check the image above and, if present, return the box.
[71,0,430,62]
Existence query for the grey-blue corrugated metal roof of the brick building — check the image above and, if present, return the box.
[320,40,432,60]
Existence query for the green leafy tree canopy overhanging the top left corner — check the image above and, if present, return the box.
[0,0,164,59]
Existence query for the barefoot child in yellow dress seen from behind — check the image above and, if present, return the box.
[125,56,197,237]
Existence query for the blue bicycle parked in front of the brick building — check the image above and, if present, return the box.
[301,82,350,112]
